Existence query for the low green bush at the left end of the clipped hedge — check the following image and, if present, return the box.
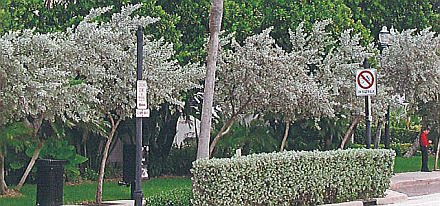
[146,187,192,206]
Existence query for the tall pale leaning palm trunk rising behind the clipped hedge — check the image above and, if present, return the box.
[197,0,223,159]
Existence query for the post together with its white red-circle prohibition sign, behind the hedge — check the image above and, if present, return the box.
[356,58,377,149]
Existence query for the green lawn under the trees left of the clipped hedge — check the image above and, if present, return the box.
[0,178,192,206]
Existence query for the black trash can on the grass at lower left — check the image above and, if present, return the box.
[36,159,67,206]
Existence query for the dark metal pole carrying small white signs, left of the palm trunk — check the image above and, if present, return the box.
[134,26,144,206]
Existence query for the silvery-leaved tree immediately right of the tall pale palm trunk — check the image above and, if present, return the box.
[210,29,287,154]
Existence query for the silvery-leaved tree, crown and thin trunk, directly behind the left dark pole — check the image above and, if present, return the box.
[68,4,203,203]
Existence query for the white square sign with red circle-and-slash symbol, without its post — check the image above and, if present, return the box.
[356,69,377,96]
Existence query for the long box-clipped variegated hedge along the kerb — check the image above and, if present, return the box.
[191,149,395,205]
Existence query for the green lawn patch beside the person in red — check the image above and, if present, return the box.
[394,156,435,173]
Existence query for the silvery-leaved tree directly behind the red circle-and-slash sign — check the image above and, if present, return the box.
[300,20,388,147]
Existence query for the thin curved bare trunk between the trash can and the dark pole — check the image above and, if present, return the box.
[96,116,121,204]
